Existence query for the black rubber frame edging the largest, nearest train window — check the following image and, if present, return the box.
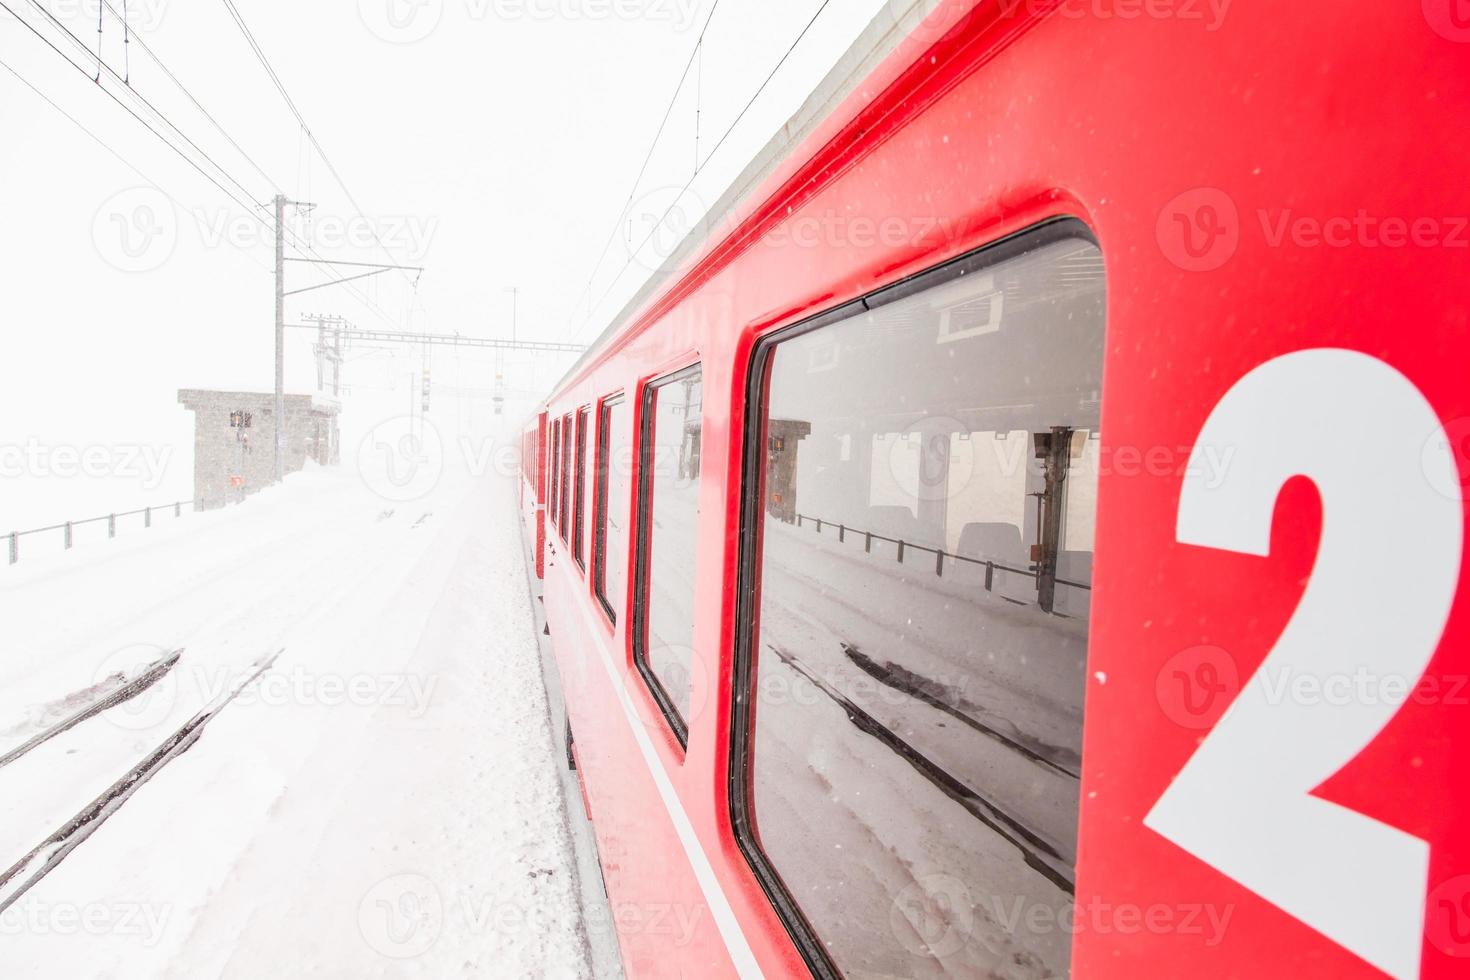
[726,215,1101,980]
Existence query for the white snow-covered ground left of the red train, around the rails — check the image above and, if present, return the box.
[0,435,602,980]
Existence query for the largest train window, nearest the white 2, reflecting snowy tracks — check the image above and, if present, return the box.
[732,222,1104,979]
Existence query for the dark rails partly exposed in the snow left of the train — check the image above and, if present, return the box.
[0,649,282,912]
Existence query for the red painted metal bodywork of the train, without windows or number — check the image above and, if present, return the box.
[528,0,1470,980]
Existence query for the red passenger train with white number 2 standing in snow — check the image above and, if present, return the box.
[523,0,1470,979]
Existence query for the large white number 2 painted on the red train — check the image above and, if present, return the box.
[1144,348,1464,977]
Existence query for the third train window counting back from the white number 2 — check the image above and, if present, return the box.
[592,395,632,623]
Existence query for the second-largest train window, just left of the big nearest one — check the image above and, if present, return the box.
[634,364,704,743]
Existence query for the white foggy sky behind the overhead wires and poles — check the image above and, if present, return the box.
[0,0,883,532]
